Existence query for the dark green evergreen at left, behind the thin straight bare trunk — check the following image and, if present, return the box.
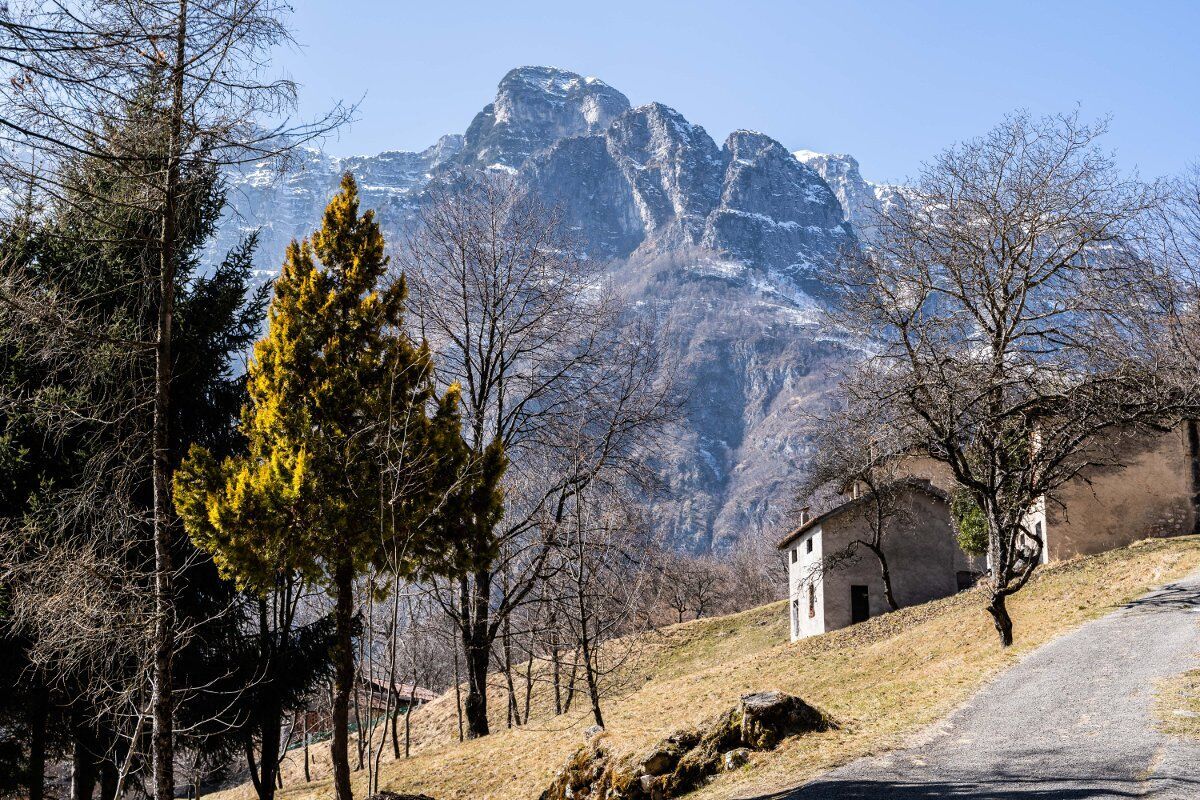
[0,84,319,800]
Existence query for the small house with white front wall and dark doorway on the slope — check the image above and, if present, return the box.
[779,477,982,640]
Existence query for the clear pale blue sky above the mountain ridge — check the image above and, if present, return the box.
[278,0,1200,181]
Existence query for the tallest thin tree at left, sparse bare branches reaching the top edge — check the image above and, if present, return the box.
[0,0,340,800]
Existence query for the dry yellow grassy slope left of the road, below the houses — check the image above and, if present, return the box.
[213,537,1200,800]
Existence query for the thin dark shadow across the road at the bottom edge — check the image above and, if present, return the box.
[751,776,1200,800]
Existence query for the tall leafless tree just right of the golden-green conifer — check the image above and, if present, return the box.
[404,174,673,738]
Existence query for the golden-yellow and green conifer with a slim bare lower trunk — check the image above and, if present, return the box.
[175,174,466,800]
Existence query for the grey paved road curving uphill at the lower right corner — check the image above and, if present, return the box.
[776,575,1200,800]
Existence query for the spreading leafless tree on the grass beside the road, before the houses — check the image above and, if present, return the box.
[829,114,1196,645]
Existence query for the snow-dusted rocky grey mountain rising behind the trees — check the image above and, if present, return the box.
[215,67,895,552]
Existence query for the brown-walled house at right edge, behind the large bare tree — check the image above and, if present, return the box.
[1025,421,1200,563]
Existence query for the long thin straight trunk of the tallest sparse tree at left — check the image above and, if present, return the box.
[150,6,187,800]
